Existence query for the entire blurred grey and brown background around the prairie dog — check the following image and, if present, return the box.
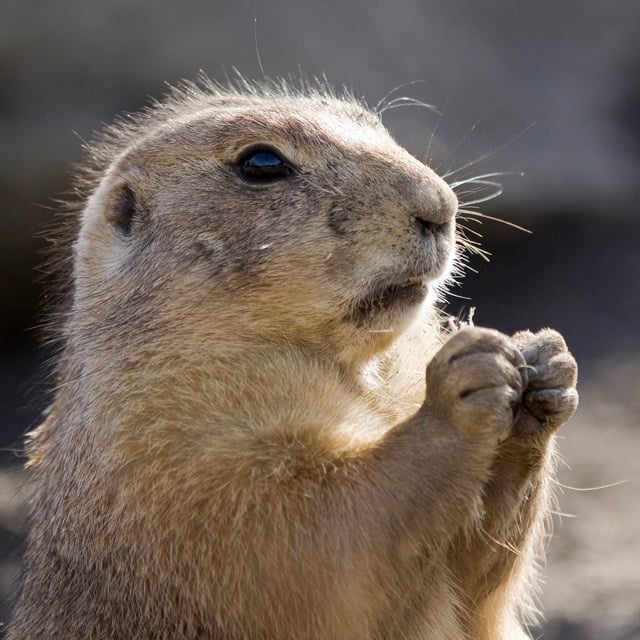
[0,0,640,640]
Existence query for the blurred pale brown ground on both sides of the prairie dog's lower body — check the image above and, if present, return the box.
[0,360,640,640]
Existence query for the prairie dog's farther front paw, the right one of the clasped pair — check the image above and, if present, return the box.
[513,329,578,432]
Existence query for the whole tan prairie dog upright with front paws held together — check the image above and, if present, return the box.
[9,81,577,640]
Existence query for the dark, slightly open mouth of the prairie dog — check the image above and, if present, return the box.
[350,276,429,322]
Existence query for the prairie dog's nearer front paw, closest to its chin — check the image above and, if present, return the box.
[427,327,527,441]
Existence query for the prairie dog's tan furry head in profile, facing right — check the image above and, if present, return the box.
[73,82,457,368]
